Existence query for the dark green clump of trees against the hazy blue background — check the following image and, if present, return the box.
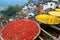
[1,5,21,16]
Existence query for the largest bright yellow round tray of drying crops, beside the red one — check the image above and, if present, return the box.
[35,14,60,24]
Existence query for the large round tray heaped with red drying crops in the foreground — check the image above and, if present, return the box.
[2,20,41,40]
